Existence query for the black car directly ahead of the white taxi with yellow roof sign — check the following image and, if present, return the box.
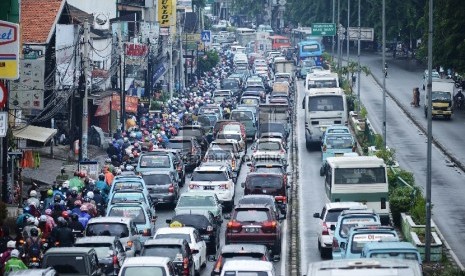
[166,210,223,254]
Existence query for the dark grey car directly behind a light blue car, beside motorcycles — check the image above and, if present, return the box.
[142,171,181,206]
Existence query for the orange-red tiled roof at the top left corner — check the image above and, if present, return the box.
[20,0,65,44]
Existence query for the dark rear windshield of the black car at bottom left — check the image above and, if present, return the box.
[45,254,90,275]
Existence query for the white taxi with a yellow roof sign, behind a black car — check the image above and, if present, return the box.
[153,226,207,273]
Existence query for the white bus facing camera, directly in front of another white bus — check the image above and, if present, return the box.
[302,88,347,150]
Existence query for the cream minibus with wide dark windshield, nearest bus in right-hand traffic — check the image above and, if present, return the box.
[325,156,389,224]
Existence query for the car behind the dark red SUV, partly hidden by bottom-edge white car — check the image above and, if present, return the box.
[209,243,271,276]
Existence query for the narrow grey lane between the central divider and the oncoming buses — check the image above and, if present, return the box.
[296,81,327,273]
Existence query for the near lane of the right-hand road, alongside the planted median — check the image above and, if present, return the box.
[361,72,465,264]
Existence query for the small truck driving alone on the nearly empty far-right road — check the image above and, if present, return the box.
[424,79,455,120]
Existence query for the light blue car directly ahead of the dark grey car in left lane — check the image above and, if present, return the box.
[135,149,182,183]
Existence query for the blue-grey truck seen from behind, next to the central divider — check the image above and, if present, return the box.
[258,104,290,140]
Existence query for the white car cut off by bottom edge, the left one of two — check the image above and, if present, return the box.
[118,257,178,276]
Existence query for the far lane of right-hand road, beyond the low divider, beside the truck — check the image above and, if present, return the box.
[360,54,465,165]
